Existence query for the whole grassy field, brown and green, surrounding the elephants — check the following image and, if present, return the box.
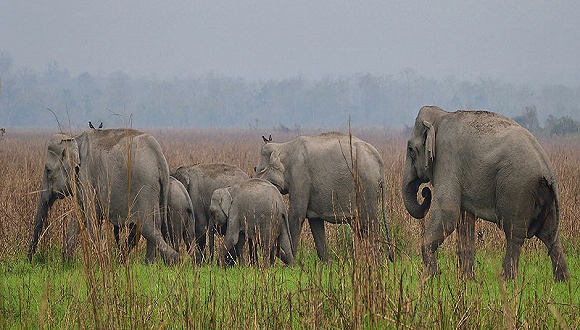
[0,129,580,329]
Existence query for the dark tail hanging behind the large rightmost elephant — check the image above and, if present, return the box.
[527,177,560,238]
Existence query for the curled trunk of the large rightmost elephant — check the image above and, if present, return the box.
[403,163,431,219]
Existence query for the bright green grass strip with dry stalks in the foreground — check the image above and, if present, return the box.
[0,246,580,329]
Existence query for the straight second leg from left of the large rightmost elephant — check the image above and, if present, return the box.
[457,211,475,279]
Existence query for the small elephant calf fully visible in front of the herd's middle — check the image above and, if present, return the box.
[209,178,294,266]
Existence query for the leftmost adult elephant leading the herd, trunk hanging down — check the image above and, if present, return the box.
[28,129,178,264]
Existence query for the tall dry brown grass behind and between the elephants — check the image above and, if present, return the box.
[0,129,580,258]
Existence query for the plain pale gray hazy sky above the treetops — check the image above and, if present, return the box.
[0,0,580,86]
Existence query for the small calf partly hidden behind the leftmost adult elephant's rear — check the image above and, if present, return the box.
[165,176,195,252]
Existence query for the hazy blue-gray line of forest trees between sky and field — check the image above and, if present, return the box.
[0,52,580,135]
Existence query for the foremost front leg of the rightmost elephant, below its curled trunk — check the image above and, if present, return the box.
[421,208,460,276]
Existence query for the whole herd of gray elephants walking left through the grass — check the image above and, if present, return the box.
[28,106,569,281]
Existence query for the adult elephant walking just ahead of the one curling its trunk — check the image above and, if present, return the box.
[255,132,392,262]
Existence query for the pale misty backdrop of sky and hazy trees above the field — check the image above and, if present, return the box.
[0,0,580,128]
